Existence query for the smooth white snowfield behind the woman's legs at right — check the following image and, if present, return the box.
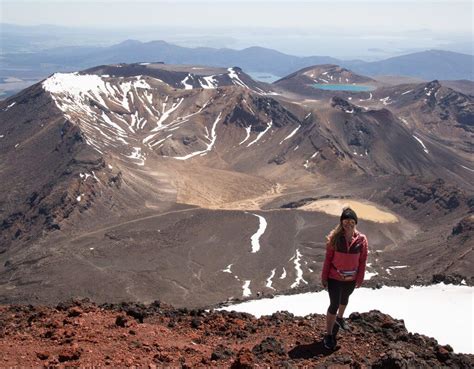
[223,284,474,354]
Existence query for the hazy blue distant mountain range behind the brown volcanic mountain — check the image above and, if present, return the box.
[0,40,474,101]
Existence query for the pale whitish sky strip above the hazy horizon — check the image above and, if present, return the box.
[1,0,473,34]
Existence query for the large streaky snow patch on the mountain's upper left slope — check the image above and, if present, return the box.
[42,73,157,165]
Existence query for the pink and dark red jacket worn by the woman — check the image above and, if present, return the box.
[321,231,368,285]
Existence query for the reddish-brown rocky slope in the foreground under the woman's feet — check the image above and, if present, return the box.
[0,300,474,368]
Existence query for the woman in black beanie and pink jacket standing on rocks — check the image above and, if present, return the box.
[321,207,368,350]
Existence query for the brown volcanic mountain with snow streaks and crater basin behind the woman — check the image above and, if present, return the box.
[0,63,474,306]
